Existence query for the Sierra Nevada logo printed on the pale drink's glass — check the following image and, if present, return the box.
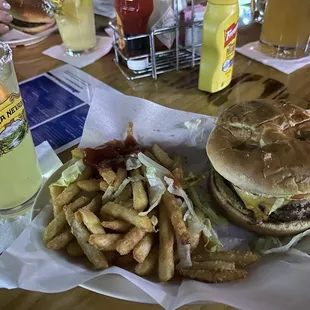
[0,93,29,157]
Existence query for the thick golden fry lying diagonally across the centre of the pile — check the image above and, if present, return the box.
[100,202,153,232]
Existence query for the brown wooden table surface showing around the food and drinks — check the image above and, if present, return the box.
[0,26,310,310]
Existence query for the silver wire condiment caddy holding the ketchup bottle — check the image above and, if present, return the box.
[110,0,202,80]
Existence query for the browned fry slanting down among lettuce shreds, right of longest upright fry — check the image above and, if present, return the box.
[162,191,190,245]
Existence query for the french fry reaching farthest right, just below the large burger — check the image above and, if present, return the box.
[192,251,260,268]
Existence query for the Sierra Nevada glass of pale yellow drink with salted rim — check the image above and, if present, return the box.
[0,42,42,217]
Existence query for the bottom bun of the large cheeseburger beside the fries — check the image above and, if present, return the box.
[210,169,310,236]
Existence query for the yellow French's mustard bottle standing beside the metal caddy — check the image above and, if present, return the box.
[198,0,239,93]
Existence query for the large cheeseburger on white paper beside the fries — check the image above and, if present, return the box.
[207,100,310,236]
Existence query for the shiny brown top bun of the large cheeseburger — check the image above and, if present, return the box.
[207,100,310,197]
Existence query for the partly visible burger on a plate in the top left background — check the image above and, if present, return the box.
[8,0,55,34]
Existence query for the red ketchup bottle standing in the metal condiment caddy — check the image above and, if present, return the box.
[115,0,154,70]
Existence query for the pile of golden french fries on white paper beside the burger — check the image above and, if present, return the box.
[43,144,259,282]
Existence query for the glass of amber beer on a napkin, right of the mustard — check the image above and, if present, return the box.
[260,0,310,59]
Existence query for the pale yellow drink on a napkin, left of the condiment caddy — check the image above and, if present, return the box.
[52,0,96,56]
